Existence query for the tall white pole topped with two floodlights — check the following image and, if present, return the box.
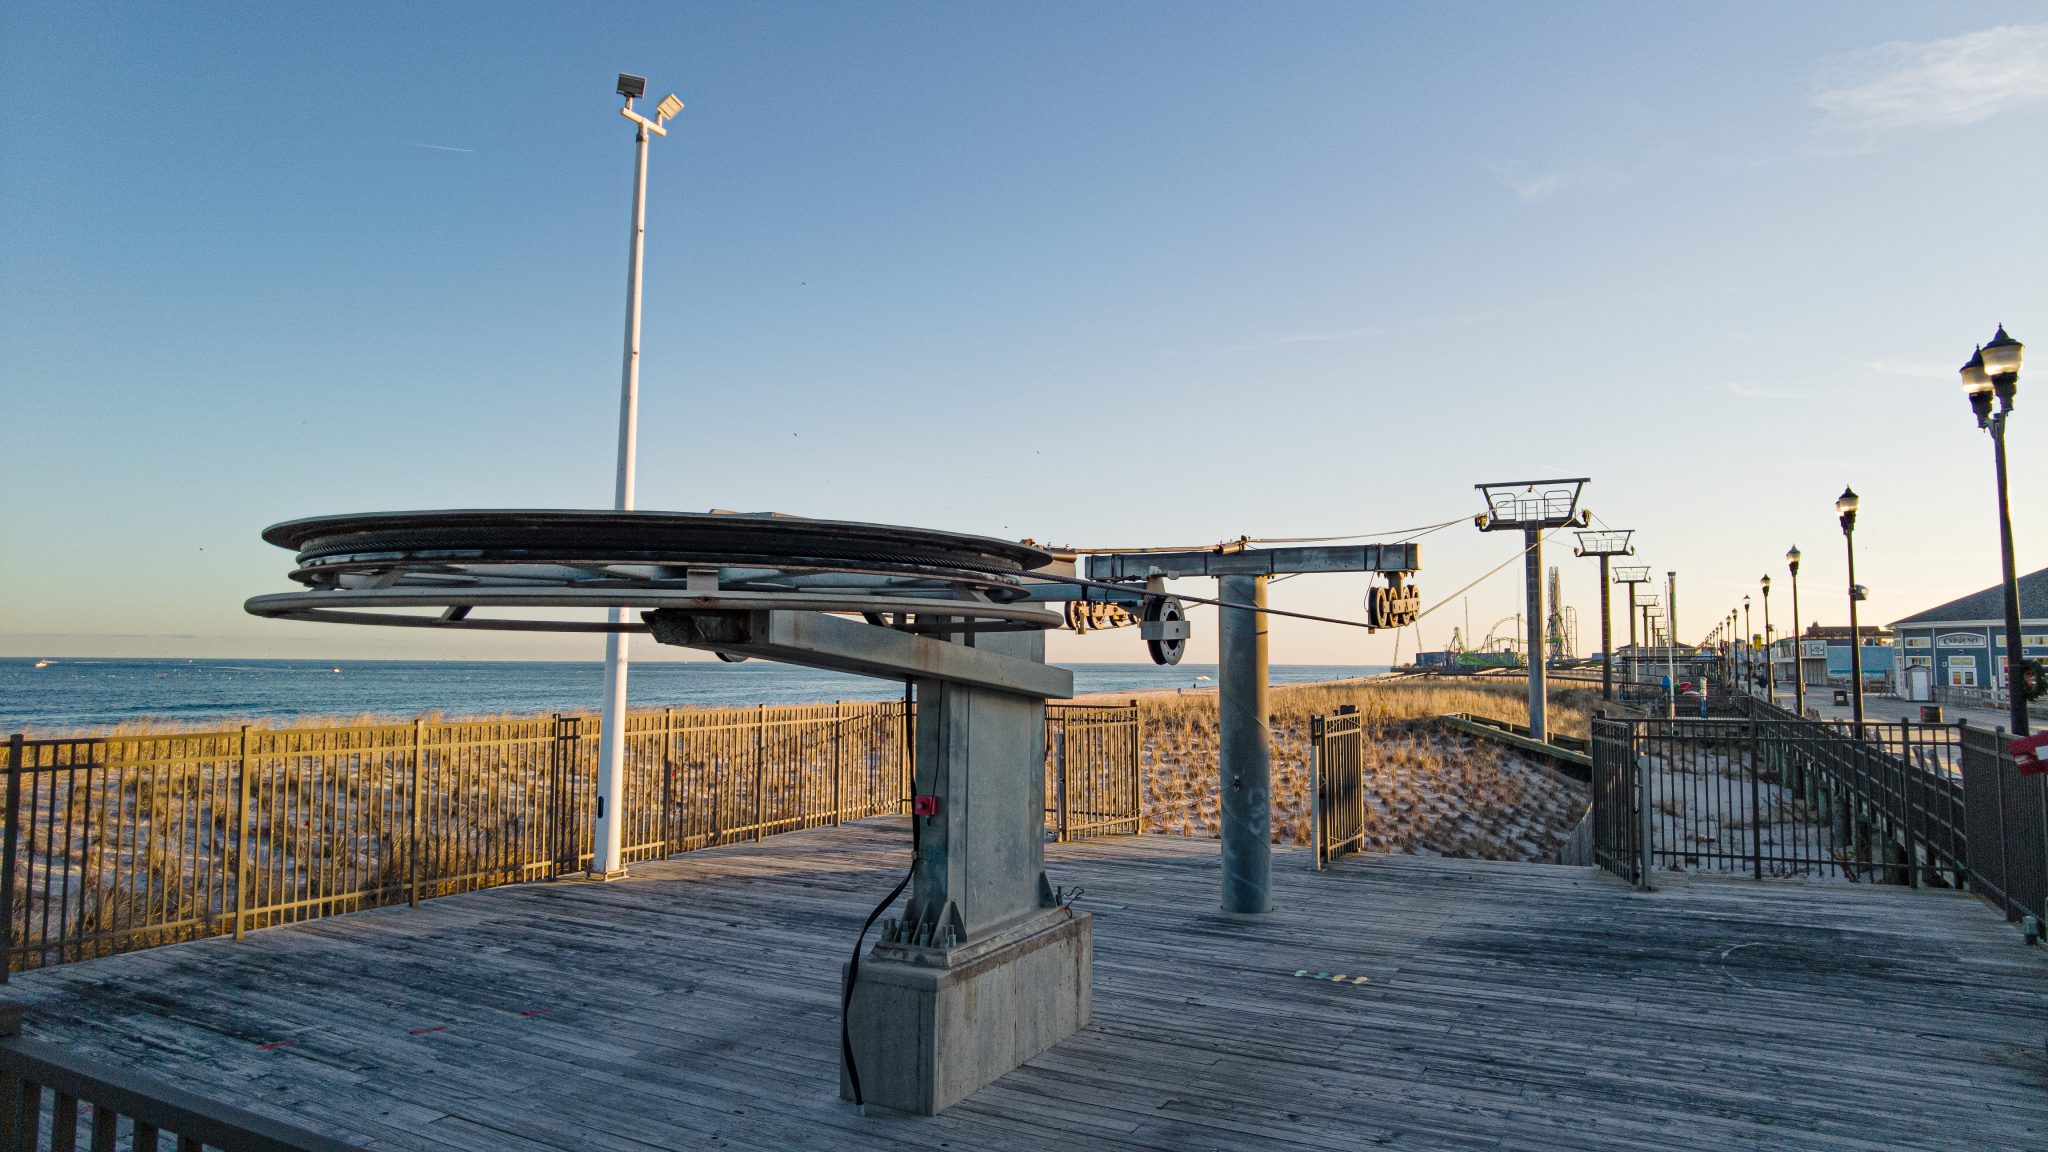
[590,74,682,879]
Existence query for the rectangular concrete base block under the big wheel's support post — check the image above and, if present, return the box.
[840,908,1096,1115]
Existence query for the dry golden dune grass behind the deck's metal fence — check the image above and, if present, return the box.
[8,681,1595,965]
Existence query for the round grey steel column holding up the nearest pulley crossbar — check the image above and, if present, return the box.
[1217,576,1274,912]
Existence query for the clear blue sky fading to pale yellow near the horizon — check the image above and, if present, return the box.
[0,2,2048,662]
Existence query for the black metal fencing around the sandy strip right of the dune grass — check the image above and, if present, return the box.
[1593,695,2048,920]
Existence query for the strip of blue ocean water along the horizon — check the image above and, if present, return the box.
[0,658,1386,732]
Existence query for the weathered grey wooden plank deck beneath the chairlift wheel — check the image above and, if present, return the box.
[6,820,2048,1152]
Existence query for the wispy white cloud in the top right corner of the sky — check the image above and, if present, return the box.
[1812,25,2048,133]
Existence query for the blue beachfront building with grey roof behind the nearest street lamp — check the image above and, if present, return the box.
[1892,568,2048,707]
